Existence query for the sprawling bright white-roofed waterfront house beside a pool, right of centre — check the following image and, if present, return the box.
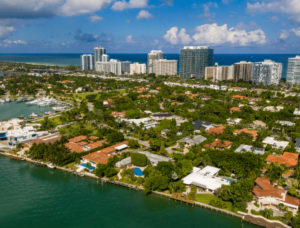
[182,166,230,192]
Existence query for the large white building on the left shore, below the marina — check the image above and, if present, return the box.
[5,127,46,146]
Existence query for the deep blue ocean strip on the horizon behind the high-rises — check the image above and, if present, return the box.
[0,54,295,78]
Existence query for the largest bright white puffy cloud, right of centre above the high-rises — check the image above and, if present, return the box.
[193,23,266,46]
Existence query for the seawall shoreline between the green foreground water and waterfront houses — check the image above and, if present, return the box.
[0,152,290,228]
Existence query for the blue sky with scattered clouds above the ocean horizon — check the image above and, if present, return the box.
[0,0,300,54]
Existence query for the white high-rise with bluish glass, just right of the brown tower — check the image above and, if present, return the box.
[253,60,282,85]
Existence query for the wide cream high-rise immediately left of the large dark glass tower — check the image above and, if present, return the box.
[153,59,178,75]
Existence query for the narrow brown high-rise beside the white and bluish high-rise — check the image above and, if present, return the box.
[233,61,253,83]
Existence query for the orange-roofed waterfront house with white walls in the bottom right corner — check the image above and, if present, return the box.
[252,177,300,214]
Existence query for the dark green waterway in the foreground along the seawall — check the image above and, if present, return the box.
[0,156,256,228]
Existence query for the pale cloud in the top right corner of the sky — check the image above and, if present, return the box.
[247,0,300,23]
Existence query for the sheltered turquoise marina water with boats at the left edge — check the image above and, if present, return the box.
[0,101,53,121]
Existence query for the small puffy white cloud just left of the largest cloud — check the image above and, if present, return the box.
[163,27,192,45]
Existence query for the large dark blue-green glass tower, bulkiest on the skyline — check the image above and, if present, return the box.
[179,46,214,79]
